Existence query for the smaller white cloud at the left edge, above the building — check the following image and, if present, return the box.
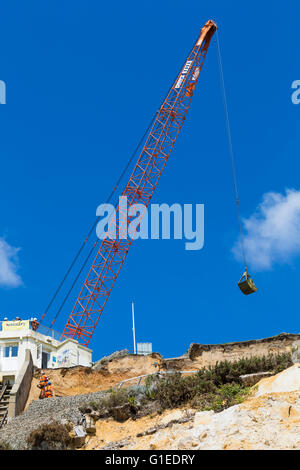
[0,238,23,287]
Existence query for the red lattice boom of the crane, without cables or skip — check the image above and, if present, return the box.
[62,20,217,346]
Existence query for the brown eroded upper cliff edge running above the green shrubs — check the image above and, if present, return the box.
[26,333,300,408]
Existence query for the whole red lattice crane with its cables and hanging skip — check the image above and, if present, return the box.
[41,20,257,346]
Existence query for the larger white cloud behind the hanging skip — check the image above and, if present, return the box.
[233,189,300,271]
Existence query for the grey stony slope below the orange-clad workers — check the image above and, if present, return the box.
[0,391,105,450]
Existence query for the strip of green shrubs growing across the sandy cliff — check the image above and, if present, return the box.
[85,353,292,419]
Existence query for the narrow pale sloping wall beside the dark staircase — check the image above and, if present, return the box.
[8,349,33,418]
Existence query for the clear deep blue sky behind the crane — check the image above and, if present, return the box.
[0,0,300,359]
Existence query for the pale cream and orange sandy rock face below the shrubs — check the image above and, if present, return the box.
[86,364,300,450]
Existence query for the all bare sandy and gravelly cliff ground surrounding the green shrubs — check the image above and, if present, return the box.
[0,334,300,449]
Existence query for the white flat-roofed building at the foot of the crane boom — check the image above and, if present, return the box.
[0,320,92,382]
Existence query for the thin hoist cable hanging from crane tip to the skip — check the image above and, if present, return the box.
[216,31,247,274]
